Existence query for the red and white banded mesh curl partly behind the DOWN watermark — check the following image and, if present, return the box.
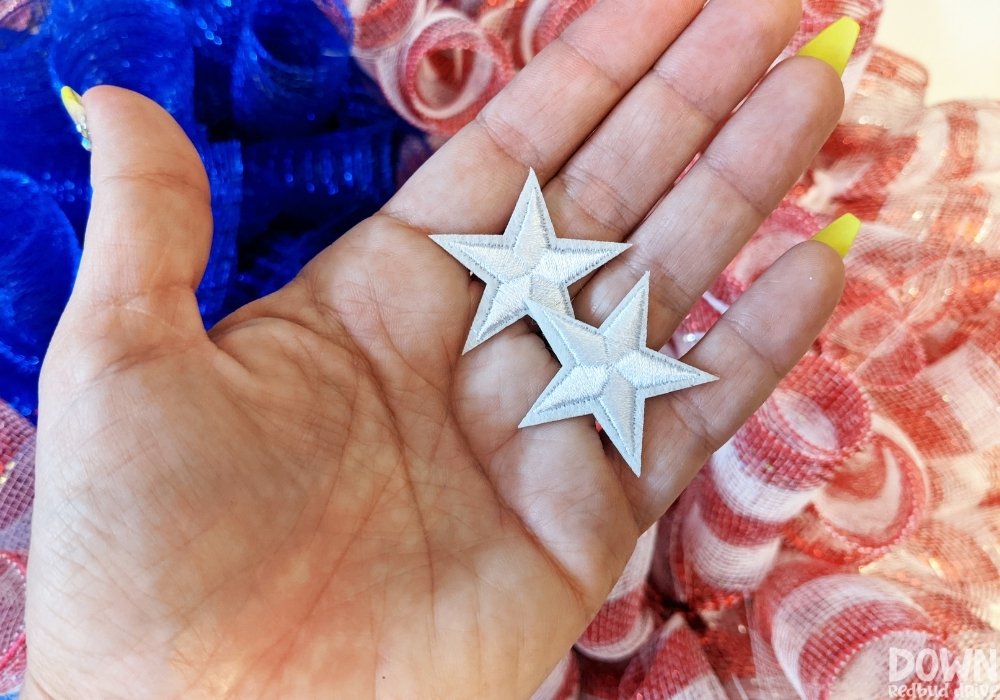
[755,560,960,700]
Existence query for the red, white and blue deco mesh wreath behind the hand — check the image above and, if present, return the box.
[0,0,1000,700]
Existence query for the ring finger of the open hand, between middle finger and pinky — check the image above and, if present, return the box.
[574,58,844,348]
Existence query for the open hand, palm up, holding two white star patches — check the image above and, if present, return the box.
[22,0,843,700]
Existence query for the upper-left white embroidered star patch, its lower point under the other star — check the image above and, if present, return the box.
[431,170,629,353]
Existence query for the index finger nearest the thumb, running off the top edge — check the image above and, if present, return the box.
[384,0,704,233]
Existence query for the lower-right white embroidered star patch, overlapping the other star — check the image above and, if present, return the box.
[519,272,718,476]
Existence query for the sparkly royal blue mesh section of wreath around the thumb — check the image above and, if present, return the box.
[0,0,419,416]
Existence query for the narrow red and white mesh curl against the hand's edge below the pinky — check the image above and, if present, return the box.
[576,527,656,661]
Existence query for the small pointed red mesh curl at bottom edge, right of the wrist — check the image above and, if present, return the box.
[618,613,727,700]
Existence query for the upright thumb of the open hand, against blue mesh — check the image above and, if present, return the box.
[69,87,212,341]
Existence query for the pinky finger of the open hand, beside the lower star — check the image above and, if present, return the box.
[617,241,844,524]
